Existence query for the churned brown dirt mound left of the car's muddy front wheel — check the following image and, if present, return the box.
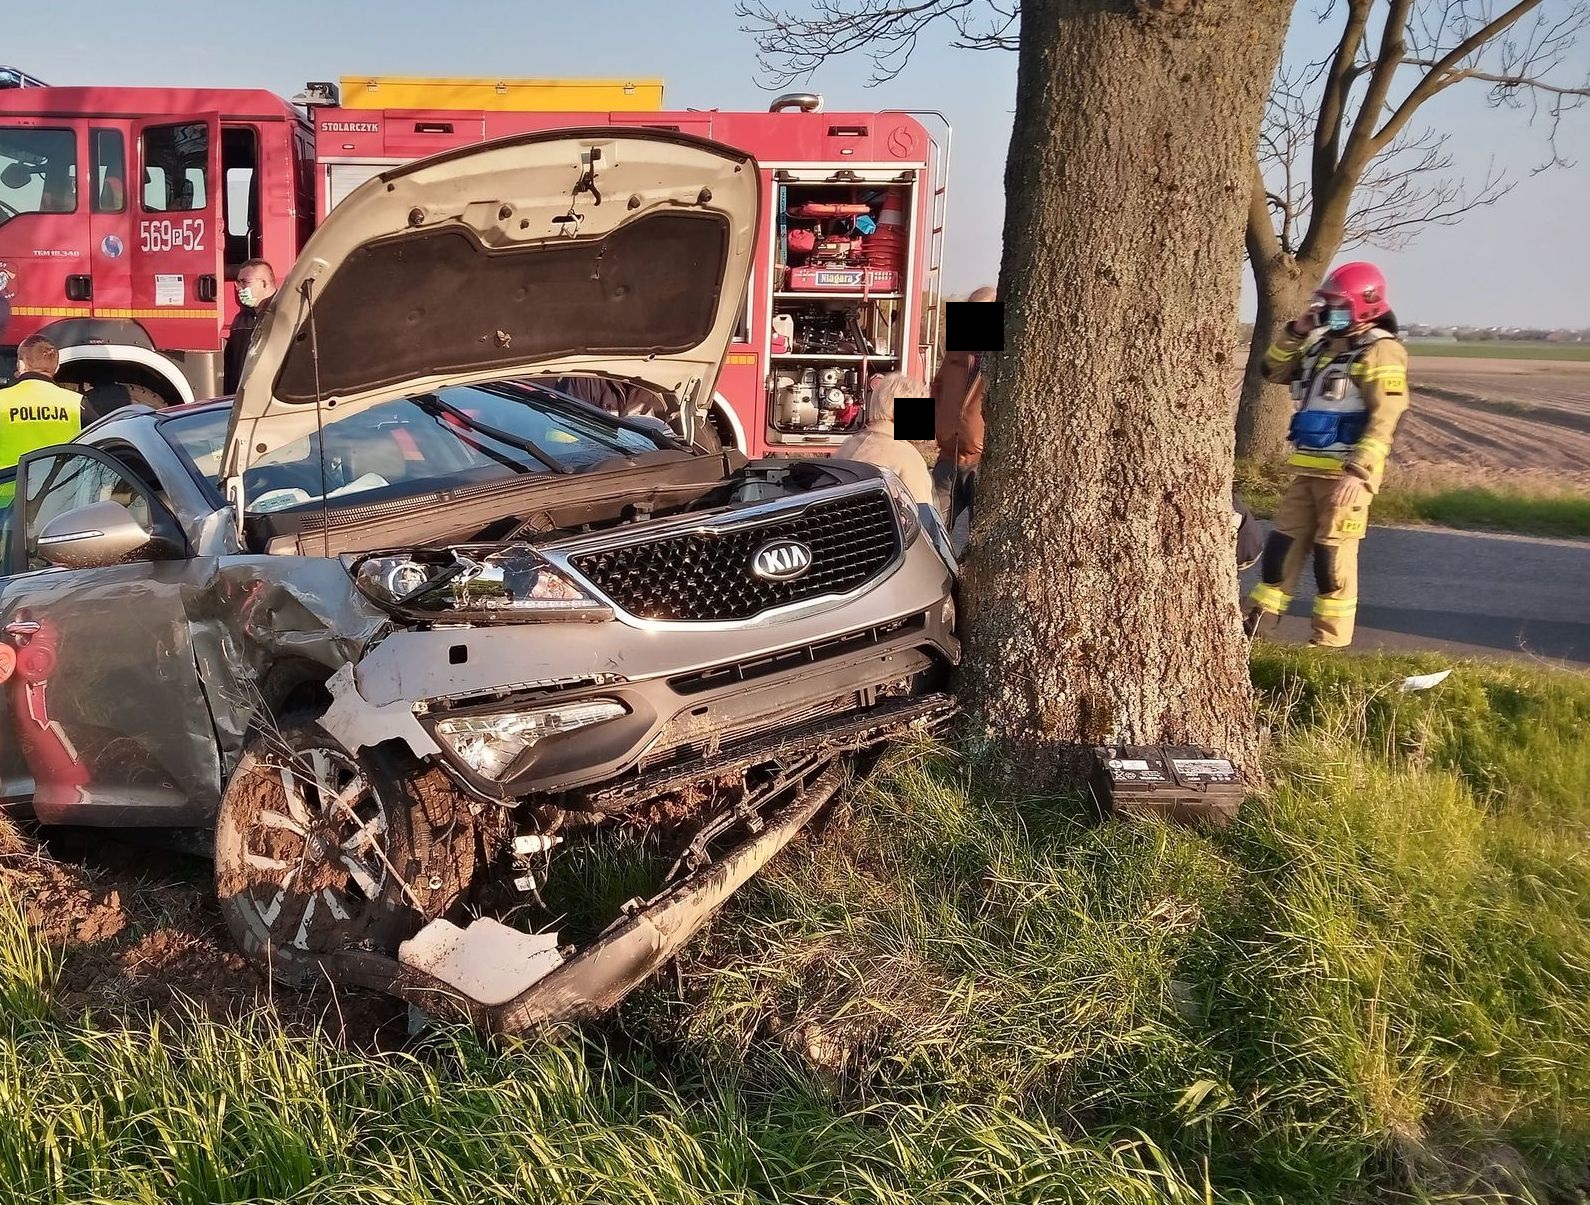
[0,817,407,1048]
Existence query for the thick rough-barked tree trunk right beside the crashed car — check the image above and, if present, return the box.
[964,0,1291,782]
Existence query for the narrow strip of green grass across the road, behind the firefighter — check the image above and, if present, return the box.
[1235,461,1590,537]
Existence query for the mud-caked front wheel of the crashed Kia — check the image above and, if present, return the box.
[215,723,475,986]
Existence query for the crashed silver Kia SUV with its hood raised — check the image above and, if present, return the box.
[0,130,959,1030]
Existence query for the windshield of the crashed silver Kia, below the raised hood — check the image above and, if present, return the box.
[161,383,669,515]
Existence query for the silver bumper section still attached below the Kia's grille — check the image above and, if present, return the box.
[321,544,960,808]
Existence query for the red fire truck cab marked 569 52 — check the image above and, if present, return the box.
[0,87,315,413]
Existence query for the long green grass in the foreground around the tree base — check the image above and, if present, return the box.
[0,645,1590,1205]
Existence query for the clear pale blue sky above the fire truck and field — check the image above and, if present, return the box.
[12,0,1590,327]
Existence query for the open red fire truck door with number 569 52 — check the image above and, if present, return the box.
[119,114,226,351]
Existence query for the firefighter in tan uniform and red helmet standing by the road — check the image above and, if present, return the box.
[1245,262,1407,649]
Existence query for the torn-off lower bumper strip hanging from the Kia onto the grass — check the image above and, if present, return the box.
[323,695,956,1035]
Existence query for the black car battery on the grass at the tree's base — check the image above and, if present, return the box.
[1088,746,1245,828]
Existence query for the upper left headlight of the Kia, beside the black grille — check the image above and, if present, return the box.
[353,544,612,620]
